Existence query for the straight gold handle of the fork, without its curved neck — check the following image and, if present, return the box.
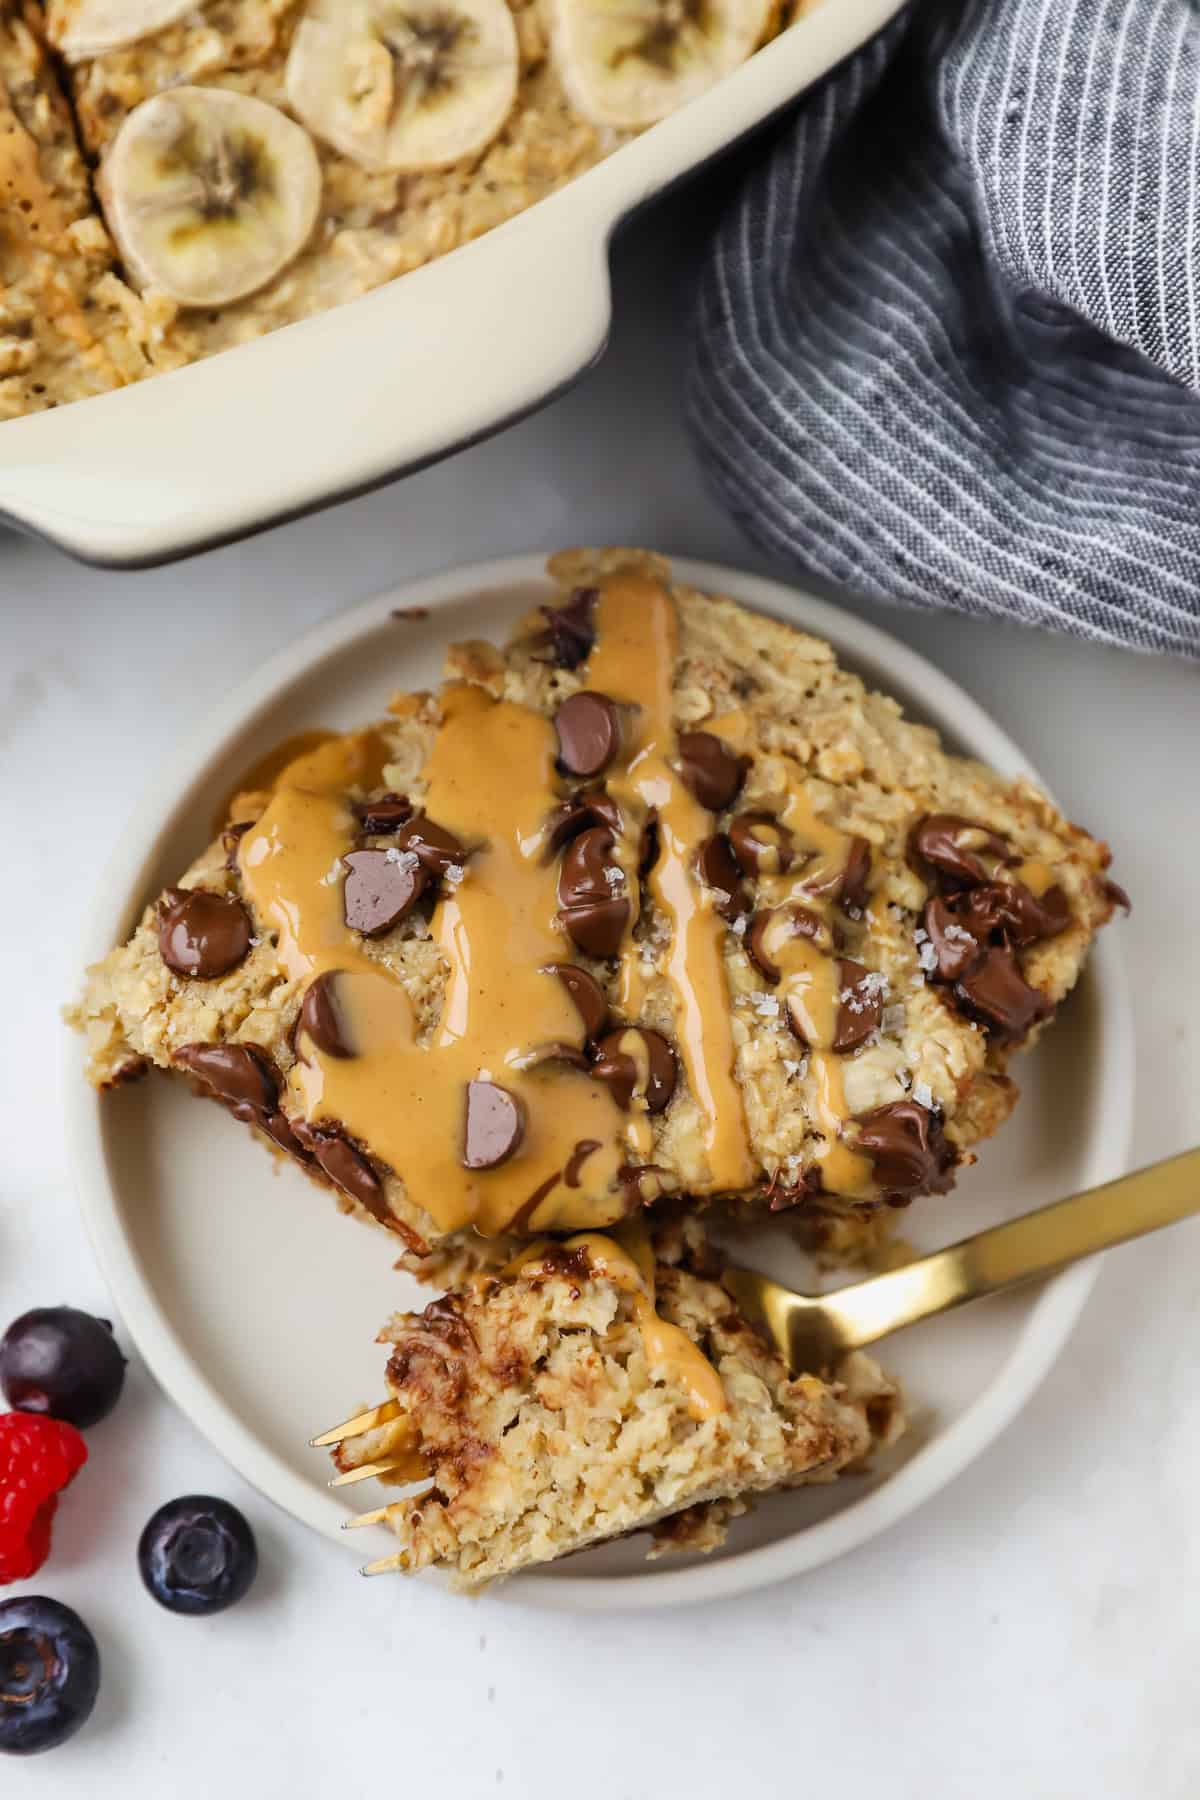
[822,1148,1200,1350]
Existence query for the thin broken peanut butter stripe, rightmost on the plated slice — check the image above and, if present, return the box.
[761,769,874,1199]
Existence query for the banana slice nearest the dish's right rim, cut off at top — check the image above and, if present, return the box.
[551,0,775,131]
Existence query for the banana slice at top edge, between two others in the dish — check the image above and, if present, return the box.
[286,0,518,171]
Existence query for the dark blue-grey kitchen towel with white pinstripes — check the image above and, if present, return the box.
[689,0,1200,657]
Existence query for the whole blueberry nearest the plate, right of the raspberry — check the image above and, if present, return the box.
[137,1494,259,1613]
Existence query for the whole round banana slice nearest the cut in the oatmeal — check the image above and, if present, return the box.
[97,88,320,306]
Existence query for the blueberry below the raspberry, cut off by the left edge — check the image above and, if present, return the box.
[0,1593,101,1757]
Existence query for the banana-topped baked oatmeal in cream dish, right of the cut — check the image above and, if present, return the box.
[0,0,780,399]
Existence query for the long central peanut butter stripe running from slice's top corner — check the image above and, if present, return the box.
[587,576,756,1192]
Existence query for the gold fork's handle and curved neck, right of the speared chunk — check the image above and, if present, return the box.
[723,1150,1200,1375]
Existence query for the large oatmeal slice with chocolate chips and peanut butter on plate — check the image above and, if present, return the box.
[76,551,1115,1267]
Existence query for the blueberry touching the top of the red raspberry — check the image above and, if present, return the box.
[0,1307,124,1431]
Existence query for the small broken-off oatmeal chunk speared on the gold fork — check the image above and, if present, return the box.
[323,1220,905,1588]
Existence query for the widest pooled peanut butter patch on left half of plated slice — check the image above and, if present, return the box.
[239,686,626,1235]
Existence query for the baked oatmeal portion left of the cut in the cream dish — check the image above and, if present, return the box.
[0,0,146,419]
